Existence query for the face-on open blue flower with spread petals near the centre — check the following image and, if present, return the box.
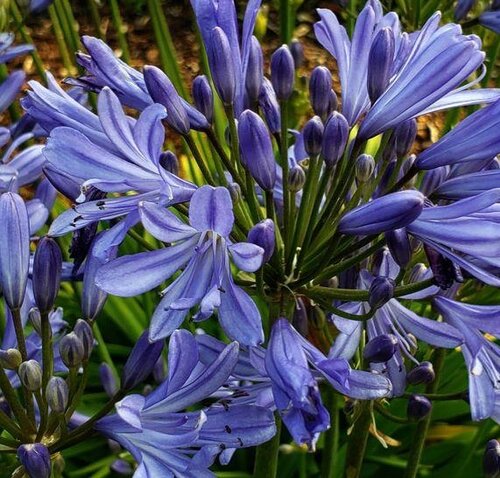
[97,186,264,345]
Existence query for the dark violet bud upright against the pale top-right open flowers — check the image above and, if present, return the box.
[367,27,395,103]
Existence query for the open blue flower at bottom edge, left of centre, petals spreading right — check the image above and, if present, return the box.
[96,330,276,478]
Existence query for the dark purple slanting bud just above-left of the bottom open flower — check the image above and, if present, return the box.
[121,330,164,391]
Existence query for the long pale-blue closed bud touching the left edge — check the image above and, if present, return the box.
[0,192,30,309]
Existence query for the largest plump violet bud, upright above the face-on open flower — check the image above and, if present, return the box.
[238,110,276,191]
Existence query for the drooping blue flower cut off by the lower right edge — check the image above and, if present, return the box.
[433,297,500,422]
